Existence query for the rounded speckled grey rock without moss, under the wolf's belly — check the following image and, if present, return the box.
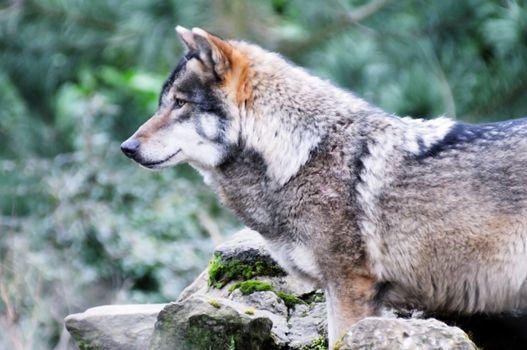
[338,317,477,350]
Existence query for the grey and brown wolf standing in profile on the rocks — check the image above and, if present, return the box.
[121,26,527,344]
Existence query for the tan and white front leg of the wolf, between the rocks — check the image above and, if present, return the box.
[325,276,377,349]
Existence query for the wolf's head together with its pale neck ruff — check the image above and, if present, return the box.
[121,27,370,186]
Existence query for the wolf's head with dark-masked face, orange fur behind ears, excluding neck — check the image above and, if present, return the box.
[121,26,250,169]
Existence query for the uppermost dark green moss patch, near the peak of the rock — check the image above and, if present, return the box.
[209,254,285,288]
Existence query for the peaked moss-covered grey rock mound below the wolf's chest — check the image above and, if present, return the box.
[151,229,327,350]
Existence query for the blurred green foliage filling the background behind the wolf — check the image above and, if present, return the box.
[0,0,527,349]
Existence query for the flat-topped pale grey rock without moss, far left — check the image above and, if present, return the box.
[65,304,166,350]
